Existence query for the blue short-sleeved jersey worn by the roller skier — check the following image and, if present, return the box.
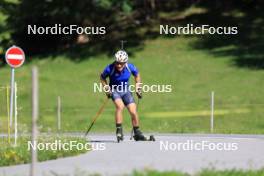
[101,63,138,86]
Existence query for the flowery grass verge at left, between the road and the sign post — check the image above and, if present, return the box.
[0,136,87,166]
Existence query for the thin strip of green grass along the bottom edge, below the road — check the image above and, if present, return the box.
[132,169,264,176]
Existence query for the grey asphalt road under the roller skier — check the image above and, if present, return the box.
[0,134,264,176]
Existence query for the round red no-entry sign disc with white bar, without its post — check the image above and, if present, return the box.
[5,46,25,68]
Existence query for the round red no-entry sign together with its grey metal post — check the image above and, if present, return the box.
[5,45,25,136]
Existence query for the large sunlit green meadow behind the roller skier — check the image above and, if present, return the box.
[0,36,264,134]
